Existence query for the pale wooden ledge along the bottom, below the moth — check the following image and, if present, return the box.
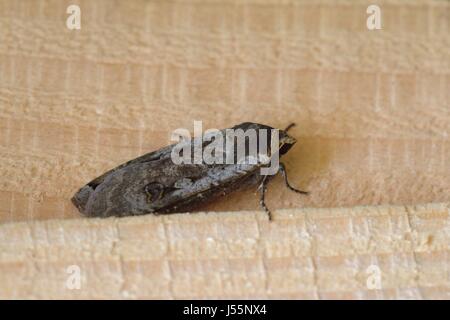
[0,204,450,299]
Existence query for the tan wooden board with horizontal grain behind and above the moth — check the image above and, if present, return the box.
[0,0,450,221]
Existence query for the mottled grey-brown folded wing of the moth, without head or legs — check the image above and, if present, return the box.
[72,122,302,217]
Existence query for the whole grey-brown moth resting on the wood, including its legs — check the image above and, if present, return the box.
[72,122,308,220]
